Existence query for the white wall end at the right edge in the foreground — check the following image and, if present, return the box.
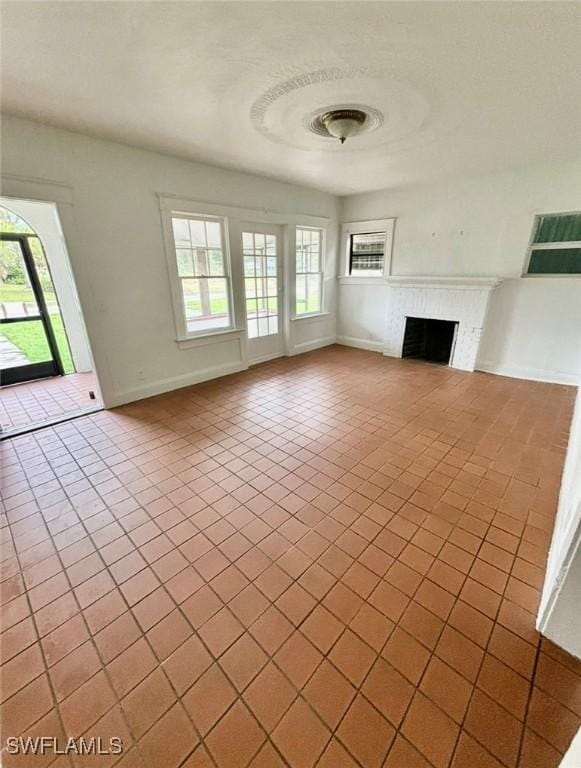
[537,388,581,658]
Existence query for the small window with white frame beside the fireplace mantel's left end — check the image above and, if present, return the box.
[342,219,394,277]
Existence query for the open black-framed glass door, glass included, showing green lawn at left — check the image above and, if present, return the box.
[0,232,64,386]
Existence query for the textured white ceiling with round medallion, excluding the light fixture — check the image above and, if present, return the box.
[1,0,581,194]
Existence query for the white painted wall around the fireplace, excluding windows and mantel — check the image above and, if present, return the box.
[337,162,581,384]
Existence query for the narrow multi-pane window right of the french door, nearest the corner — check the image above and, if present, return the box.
[295,227,323,316]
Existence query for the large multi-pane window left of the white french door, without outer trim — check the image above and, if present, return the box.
[172,214,231,334]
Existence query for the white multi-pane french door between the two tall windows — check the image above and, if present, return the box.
[242,222,285,363]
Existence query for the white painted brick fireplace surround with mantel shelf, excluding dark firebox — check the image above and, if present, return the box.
[383,275,501,371]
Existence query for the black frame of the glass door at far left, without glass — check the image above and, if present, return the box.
[0,232,65,387]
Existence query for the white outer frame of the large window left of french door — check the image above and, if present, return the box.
[162,209,235,341]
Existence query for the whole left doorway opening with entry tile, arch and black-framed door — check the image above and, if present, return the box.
[0,198,102,437]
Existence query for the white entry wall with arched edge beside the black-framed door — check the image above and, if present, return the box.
[0,197,93,373]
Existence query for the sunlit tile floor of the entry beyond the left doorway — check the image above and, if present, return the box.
[0,373,99,433]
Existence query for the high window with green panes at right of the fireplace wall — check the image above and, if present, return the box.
[526,213,581,275]
